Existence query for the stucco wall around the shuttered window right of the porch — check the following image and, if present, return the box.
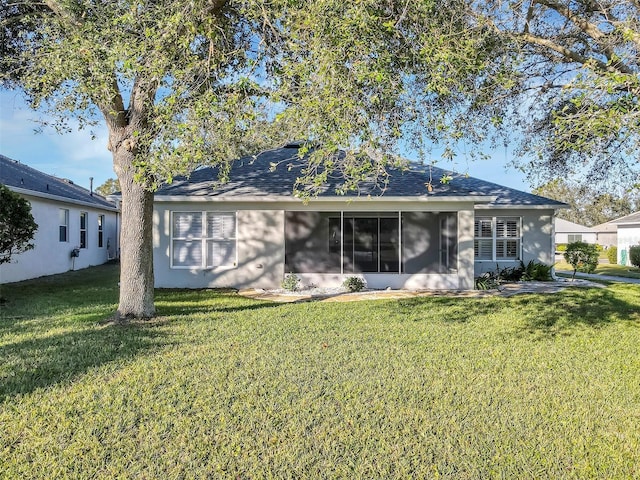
[475,209,555,277]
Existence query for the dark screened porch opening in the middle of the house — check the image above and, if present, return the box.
[285,212,458,274]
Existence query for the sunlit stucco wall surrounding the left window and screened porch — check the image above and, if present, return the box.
[153,199,484,289]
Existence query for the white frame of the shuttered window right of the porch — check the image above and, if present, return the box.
[473,215,522,262]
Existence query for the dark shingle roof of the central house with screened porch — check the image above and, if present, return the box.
[156,147,566,208]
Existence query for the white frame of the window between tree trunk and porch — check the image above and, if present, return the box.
[169,210,238,270]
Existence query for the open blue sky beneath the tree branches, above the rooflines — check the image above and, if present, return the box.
[0,90,531,192]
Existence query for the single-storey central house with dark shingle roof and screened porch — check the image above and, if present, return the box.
[153,144,566,290]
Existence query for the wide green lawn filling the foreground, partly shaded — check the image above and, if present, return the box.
[0,266,640,479]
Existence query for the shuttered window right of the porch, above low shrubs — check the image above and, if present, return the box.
[473,217,522,261]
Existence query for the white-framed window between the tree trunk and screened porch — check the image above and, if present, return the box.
[171,212,237,268]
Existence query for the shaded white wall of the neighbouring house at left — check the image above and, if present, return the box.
[0,195,118,283]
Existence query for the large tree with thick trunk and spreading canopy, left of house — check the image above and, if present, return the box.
[0,0,493,317]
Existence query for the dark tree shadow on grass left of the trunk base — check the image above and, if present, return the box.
[0,322,171,402]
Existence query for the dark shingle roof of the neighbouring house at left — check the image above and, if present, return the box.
[0,155,115,210]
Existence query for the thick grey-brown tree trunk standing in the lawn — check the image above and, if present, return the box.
[111,142,155,319]
